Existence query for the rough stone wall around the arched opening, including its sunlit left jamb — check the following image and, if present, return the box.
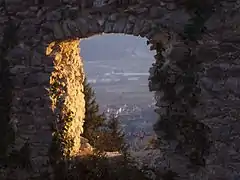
[0,0,240,180]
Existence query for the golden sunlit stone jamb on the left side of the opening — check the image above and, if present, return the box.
[46,39,85,158]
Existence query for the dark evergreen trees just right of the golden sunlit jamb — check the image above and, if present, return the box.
[82,79,125,151]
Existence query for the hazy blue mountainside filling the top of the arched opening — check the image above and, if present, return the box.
[80,34,151,61]
